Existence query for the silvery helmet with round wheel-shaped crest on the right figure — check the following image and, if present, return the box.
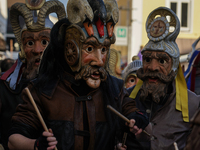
[142,7,180,73]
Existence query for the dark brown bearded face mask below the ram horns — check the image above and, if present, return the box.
[22,29,51,79]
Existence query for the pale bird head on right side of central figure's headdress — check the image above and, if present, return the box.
[103,0,119,24]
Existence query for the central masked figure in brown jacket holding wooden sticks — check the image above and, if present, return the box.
[9,0,148,150]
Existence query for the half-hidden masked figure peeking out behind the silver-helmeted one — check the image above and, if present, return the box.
[122,56,142,88]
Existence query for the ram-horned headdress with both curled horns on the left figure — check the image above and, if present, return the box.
[10,0,66,61]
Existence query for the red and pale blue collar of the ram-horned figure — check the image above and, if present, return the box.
[1,55,24,90]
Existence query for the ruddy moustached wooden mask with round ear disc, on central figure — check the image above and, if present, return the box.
[64,25,113,89]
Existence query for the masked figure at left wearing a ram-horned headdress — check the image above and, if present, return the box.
[0,0,66,149]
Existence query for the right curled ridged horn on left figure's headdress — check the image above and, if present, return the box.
[37,1,66,27]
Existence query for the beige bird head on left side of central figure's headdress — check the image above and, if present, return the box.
[67,0,94,23]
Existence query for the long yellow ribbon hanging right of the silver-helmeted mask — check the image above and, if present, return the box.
[175,63,189,122]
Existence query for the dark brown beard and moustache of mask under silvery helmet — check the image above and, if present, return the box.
[137,68,176,103]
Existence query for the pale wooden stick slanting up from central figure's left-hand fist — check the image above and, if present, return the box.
[25,87,58,150]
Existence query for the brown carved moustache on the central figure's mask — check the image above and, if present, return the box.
[75,65,107,85]
